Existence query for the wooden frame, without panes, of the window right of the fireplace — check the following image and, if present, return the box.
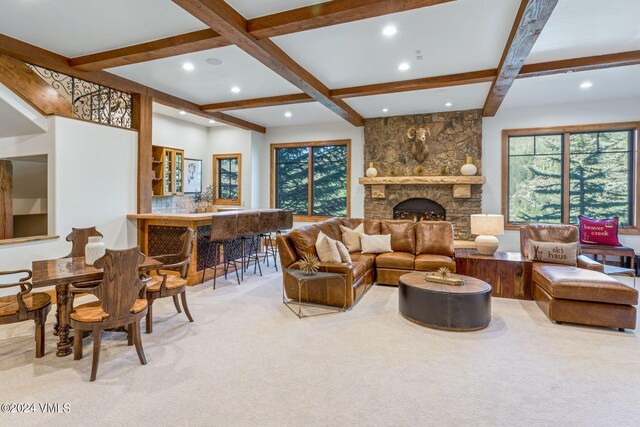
[502,122,640,234]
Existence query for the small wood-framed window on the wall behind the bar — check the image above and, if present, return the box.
[213,154,242,205]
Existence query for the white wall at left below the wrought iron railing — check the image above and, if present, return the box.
[0,117,137,290]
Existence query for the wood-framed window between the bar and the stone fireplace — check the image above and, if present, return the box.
[271,141,350,220]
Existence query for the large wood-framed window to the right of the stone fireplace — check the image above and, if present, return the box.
[503,123,638,232]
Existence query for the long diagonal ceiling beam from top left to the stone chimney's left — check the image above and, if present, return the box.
[173,0,364,126]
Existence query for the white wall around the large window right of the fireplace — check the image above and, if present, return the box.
[482,99,640,252]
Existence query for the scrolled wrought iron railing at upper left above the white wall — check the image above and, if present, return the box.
[27,64,133,128]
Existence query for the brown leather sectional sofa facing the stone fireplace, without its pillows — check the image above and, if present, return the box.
[277,218,456,307]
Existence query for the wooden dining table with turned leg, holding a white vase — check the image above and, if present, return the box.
[31,257,162,357]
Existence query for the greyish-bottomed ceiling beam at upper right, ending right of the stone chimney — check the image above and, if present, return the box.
[482,0,558,117]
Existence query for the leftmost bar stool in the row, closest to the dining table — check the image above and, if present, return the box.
[202,213,240,289]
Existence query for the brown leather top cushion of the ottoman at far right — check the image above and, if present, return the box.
[533,263,638,305]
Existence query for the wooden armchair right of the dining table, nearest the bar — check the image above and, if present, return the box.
[147,228,196,334]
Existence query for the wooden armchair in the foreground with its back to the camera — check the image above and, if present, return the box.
[69,247,147,381]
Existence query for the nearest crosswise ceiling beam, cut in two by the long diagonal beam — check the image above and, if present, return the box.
[70,0,455,71]
